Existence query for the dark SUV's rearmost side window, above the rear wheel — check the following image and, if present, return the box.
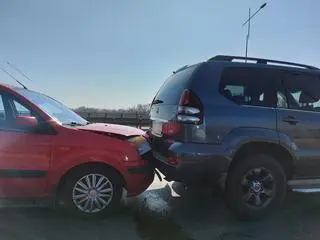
[219,68,276,107]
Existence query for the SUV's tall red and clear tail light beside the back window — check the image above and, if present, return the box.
[177,89,203,124]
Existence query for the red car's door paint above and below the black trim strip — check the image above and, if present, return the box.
[0,131,53,198]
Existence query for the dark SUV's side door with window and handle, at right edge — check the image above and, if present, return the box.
[277,72,320,177]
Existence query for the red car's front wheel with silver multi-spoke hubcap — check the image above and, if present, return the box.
[58,166,123,219]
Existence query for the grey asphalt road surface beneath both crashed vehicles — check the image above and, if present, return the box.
[0,180,320,240]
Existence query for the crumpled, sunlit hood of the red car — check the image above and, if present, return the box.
[77,123,145,137]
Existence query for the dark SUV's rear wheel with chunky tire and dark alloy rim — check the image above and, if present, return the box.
[225,154,286,220]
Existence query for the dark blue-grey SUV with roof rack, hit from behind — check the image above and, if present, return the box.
[150,55,320,219]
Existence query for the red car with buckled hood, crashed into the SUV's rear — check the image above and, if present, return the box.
[0,84,154,217]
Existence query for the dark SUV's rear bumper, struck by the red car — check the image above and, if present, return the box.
[152,143,231,182]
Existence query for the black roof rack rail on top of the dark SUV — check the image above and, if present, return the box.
[208,55,319,70]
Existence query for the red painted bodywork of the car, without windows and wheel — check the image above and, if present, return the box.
[0,85,154,201]
